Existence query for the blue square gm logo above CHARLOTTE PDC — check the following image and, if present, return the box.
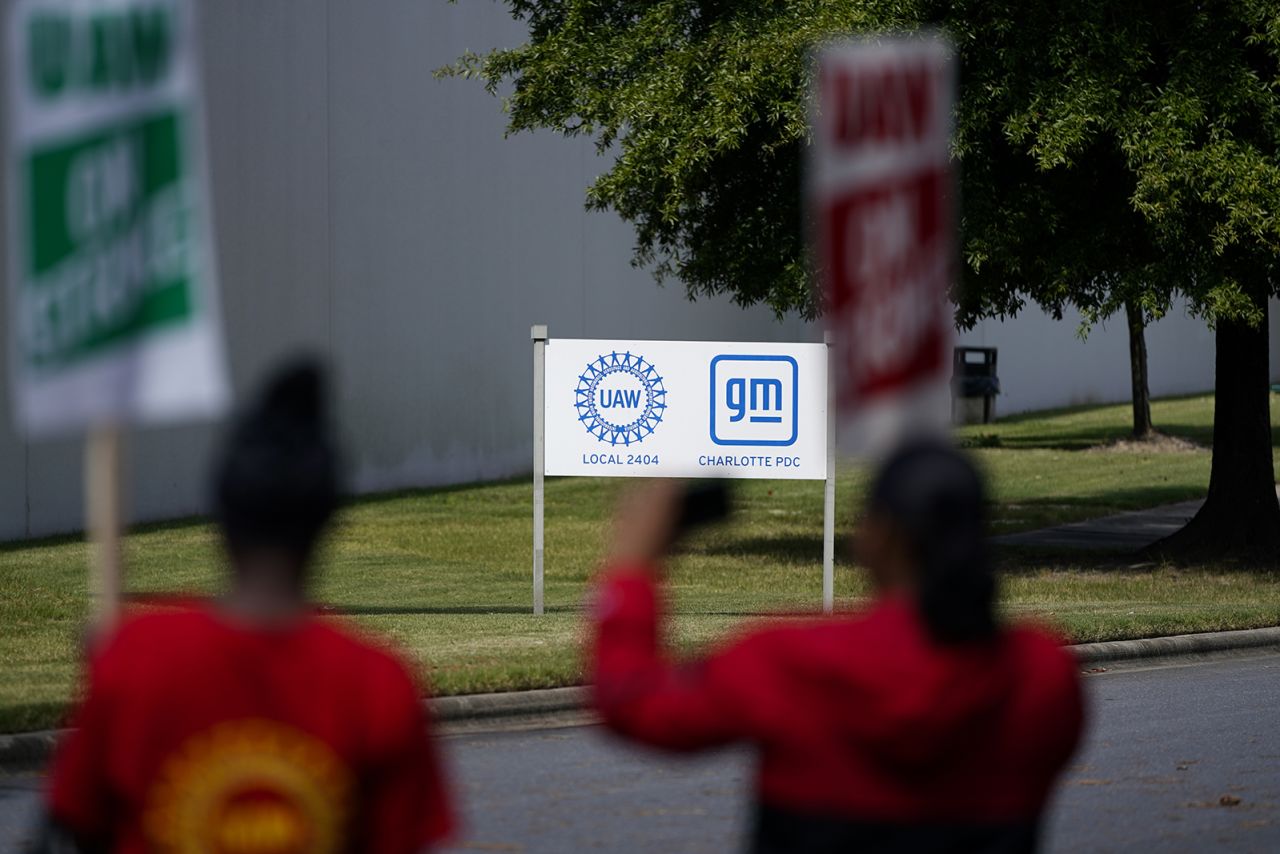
[712,356,800,447]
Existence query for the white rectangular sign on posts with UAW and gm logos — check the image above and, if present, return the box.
[545,338,827,480]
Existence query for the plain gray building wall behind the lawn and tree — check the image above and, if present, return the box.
[0,0,1280,539]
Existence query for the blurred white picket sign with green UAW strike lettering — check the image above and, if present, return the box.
[5,0,227,435]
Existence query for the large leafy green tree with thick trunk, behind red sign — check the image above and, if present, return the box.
[447,0,1280,561]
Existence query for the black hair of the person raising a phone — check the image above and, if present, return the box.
[869,440,998,644]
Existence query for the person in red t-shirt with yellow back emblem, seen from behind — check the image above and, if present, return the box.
[49,365,453,854]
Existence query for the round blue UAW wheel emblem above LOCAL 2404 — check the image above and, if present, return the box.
[573,352,667,446]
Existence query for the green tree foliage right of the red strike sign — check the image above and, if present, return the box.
[947,0,1280,323]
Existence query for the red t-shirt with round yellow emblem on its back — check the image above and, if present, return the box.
[49,609,452,854]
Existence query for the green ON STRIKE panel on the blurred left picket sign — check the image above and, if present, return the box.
[26,113,193,367]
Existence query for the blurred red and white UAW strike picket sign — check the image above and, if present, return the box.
[808,36,955,455]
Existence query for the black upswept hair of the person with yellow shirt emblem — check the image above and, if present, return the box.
[212,360,339,563]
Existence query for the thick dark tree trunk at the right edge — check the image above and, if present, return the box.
[1155,303,1280,566]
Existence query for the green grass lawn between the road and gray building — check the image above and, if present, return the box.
[0,397,1280,731]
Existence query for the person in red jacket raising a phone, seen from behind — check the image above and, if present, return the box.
[593,444,1083,851]
